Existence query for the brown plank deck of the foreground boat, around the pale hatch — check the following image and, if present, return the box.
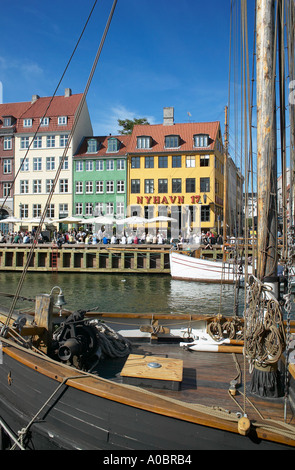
[98,343,295,425]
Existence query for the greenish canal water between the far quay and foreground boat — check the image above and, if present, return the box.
[0,271,244,315]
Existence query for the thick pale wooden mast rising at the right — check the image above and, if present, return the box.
[256,0,278,283]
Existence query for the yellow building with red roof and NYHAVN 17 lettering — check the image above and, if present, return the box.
[127,108,224,238]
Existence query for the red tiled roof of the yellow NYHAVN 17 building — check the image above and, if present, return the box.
[128,121,220,153]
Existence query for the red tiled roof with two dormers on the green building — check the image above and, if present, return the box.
[74,134,131,159]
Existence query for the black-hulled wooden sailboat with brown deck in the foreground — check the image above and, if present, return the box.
[0,0,295,450]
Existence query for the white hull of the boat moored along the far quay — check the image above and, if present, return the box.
[170,251,252,284]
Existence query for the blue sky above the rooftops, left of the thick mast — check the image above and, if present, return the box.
[0,0,236,135]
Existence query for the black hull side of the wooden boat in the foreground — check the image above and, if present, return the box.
[0,346,292,451]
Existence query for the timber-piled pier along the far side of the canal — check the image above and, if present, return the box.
[0,243,247,274]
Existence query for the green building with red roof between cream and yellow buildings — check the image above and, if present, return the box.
[73,135,130,224]
